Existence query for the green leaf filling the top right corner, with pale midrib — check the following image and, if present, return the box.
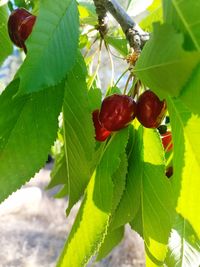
[163,0,200,51]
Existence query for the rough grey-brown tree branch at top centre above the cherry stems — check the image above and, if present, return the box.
[93,0,149,52]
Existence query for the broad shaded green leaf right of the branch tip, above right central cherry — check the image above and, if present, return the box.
[135,24,200,96]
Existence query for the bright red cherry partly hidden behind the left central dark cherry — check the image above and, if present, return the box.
[92,109,111,142]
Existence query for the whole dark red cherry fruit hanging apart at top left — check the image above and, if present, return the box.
[8,8,36,53]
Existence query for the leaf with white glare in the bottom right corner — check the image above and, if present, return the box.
[165,215,200,267]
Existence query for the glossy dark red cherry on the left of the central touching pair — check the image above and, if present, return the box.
[99,94,136,131]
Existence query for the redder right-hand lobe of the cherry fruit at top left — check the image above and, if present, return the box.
[18,15,36,52]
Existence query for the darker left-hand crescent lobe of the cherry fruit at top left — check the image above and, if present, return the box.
[8,8,31,48]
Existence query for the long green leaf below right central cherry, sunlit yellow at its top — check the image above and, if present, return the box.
[122,126,174,266]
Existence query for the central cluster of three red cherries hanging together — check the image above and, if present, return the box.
[93,90,167,142]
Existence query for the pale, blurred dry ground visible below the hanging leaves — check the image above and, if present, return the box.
[0,164,145,267]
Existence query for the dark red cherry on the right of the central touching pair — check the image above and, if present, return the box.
[137,90,167,128]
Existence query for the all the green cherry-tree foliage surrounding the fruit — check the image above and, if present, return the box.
[0,0,200,267]
